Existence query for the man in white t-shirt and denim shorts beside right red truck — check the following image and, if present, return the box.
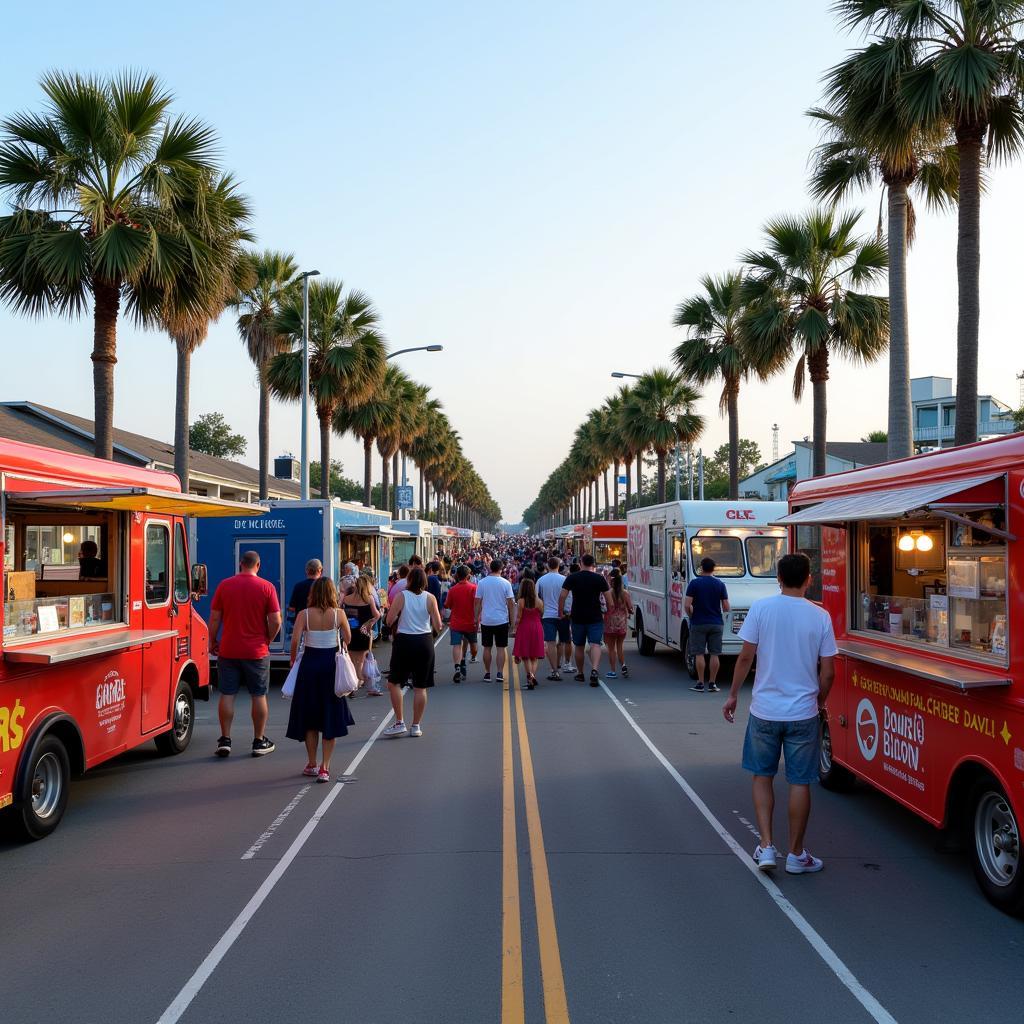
[722,553,837,874]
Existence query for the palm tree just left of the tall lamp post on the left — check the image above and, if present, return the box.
[228,250,299,504]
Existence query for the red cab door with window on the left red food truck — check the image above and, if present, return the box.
[142,518,176,733]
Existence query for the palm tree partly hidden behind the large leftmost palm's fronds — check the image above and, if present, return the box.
[160,175,250,492]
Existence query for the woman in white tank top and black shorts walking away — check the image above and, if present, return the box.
[381,565,443,737]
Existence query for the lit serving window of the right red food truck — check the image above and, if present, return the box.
[851,506,1010,664]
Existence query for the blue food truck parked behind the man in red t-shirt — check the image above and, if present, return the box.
[190,499,399,660]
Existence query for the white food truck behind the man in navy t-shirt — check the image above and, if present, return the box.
[626,501,787,678]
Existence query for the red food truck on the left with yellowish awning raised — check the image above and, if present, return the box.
[0,440,265,839]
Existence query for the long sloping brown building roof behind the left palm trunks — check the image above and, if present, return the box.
[0,401,299,497]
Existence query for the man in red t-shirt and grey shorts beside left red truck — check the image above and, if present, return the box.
[210,551,281,758]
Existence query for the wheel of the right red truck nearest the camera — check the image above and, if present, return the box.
[970,778,1024,916]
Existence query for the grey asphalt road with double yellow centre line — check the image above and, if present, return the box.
[0,639,1024,1024]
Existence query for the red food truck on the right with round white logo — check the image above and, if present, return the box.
[781,434,1024,913]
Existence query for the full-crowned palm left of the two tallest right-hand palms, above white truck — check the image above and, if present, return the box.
[742,210,889,476]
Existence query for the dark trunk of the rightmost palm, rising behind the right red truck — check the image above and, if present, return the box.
[953,126,984,444]
